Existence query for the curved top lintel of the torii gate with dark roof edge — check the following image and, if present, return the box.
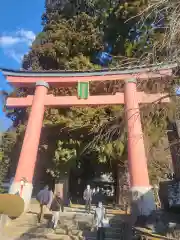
[1,64,177,87]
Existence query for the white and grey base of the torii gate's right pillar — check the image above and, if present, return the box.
[131,186,156,217]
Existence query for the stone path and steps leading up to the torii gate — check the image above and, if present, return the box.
[0,203,131,240]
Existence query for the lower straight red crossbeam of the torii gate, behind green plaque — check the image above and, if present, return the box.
[6,92,170,107]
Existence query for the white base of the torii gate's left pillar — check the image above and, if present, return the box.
[9,182,33,211]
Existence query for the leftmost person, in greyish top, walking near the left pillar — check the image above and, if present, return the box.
[36,186,52,223]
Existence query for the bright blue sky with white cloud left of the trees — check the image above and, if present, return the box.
[0,0,45,132]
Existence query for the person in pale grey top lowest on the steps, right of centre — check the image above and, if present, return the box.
[94,202,109,240]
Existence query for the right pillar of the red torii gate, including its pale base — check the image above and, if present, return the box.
[124,78,156,216]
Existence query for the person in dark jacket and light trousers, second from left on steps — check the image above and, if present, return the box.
[50,192,64,229]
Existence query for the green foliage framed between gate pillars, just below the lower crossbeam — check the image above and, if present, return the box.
[44,106,125,178]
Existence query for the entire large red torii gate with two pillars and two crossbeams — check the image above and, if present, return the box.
[2,64,176,215]
